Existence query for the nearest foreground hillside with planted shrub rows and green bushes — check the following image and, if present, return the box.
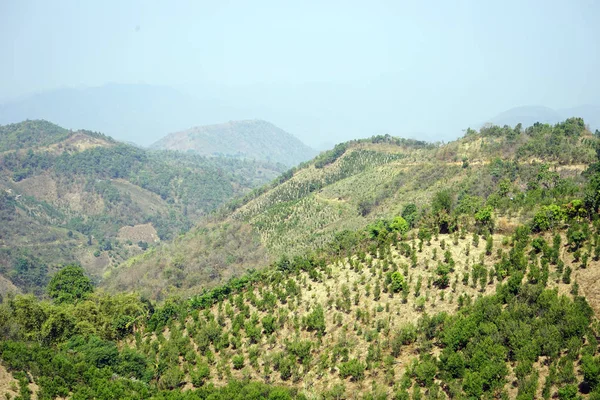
[0,175,600,400]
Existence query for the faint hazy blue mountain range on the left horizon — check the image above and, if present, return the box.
[0,84,230,146]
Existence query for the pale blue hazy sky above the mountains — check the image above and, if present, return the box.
[0,0,600,145]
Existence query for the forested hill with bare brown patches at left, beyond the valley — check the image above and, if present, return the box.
[0,121,282,293]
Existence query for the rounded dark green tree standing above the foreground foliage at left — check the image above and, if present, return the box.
[47,265,94,303]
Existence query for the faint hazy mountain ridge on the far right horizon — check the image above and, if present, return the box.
[485,105,600,131]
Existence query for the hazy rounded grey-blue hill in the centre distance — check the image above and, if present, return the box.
[151,120,316,167]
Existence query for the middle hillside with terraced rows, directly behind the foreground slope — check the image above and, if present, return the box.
[106,119,595,297]
